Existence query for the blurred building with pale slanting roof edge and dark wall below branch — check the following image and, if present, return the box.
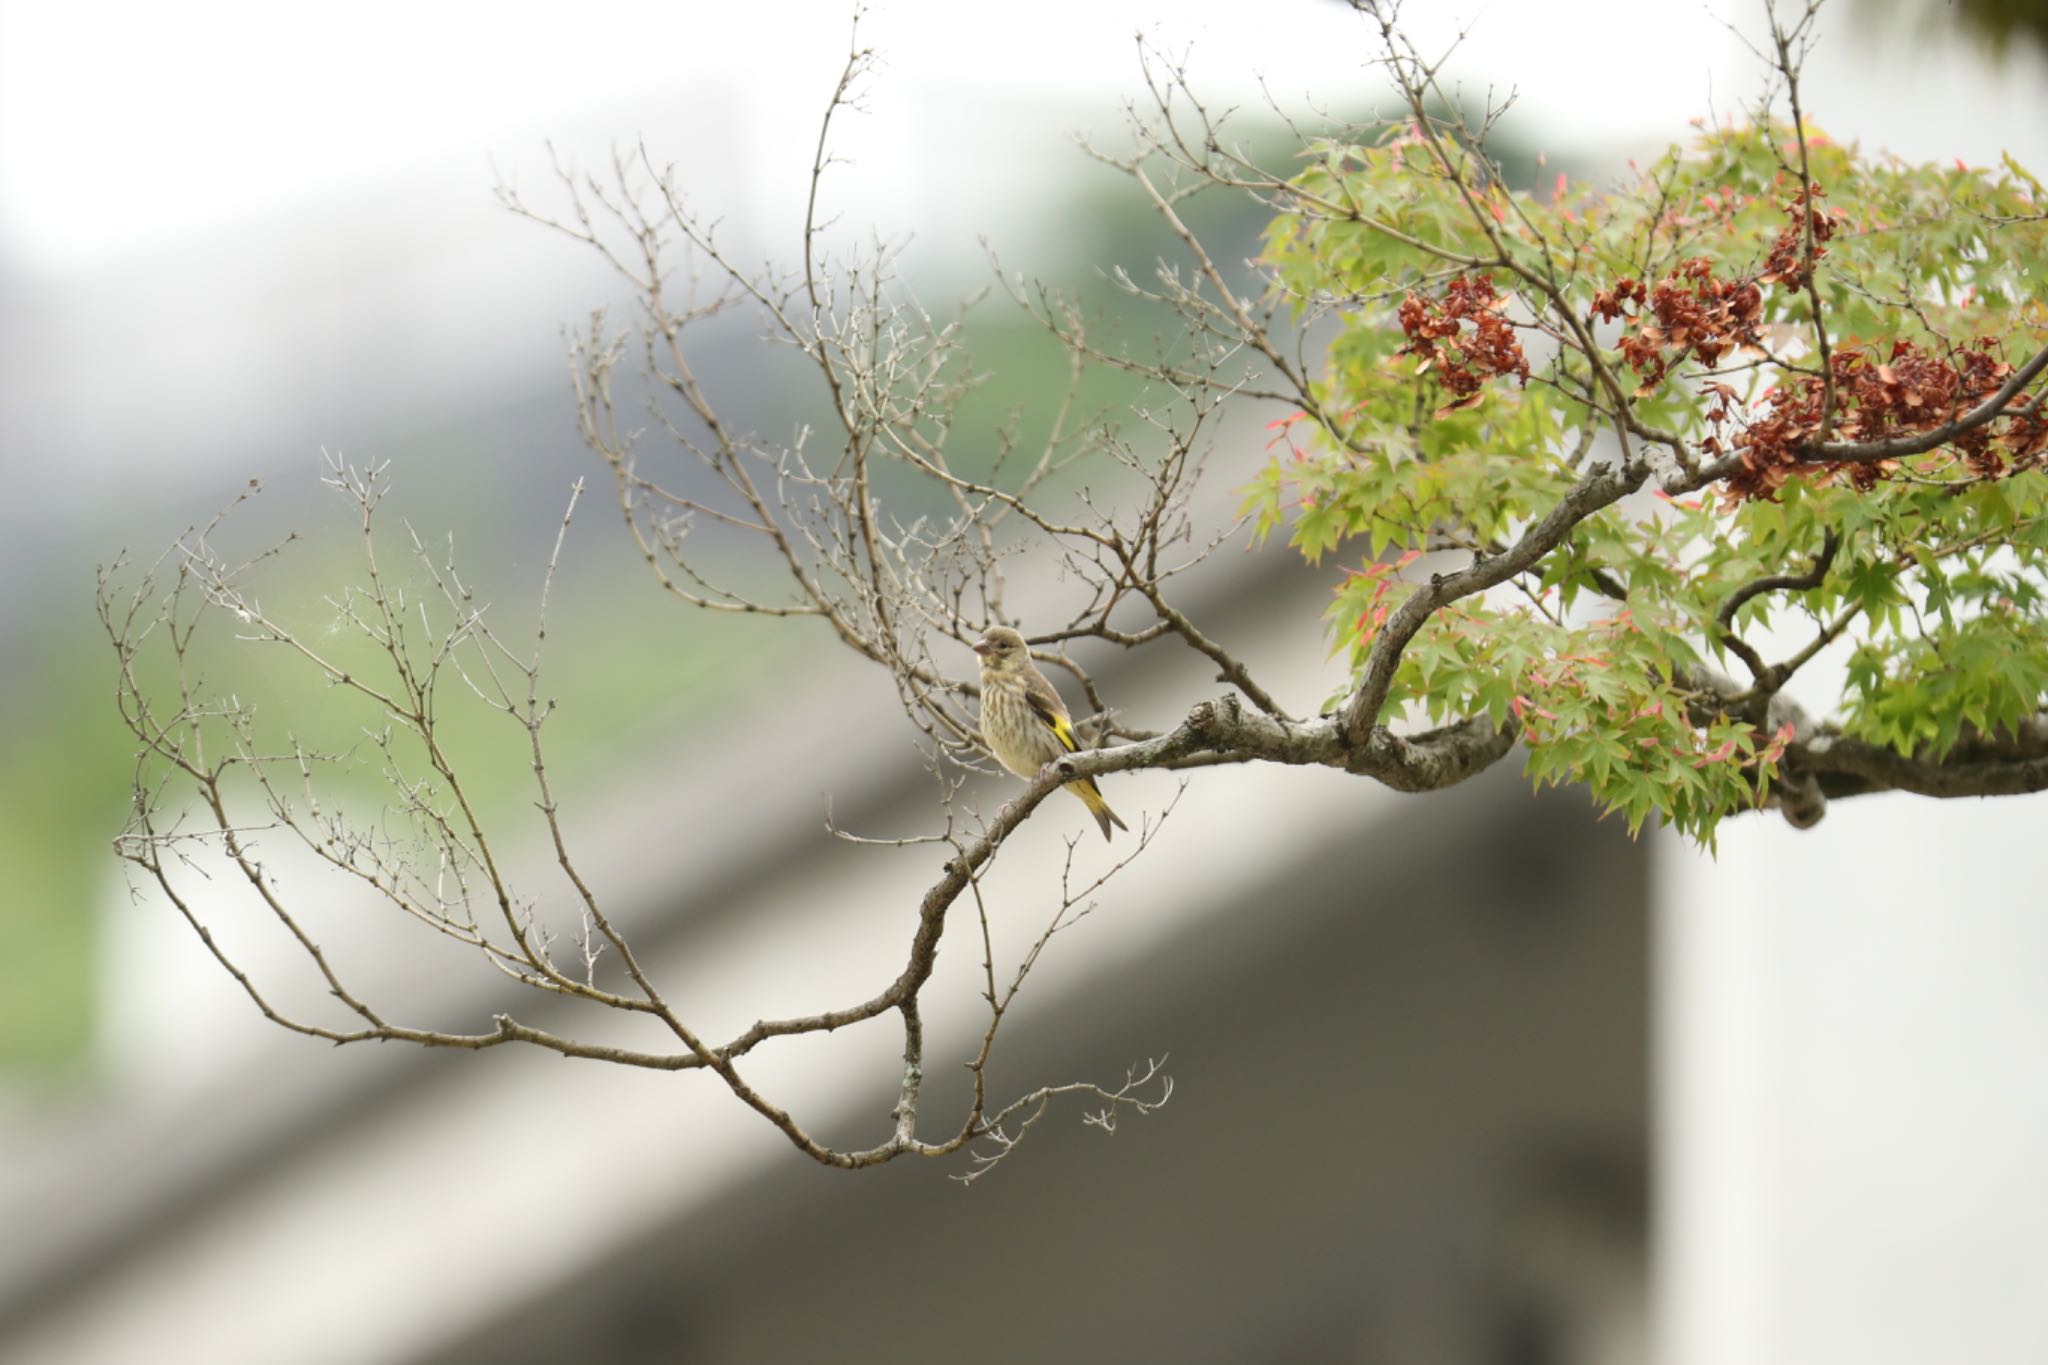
[0,671,1649,1365]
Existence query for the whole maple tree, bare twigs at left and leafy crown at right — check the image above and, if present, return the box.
[100,0,2048,1166]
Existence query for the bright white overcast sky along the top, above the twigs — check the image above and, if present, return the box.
[0,0,1761,270]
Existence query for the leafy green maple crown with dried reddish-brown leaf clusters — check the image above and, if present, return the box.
[1251,8,2048,839]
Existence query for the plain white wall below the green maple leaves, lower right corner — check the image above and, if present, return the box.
[1655,796,2048,1365]
